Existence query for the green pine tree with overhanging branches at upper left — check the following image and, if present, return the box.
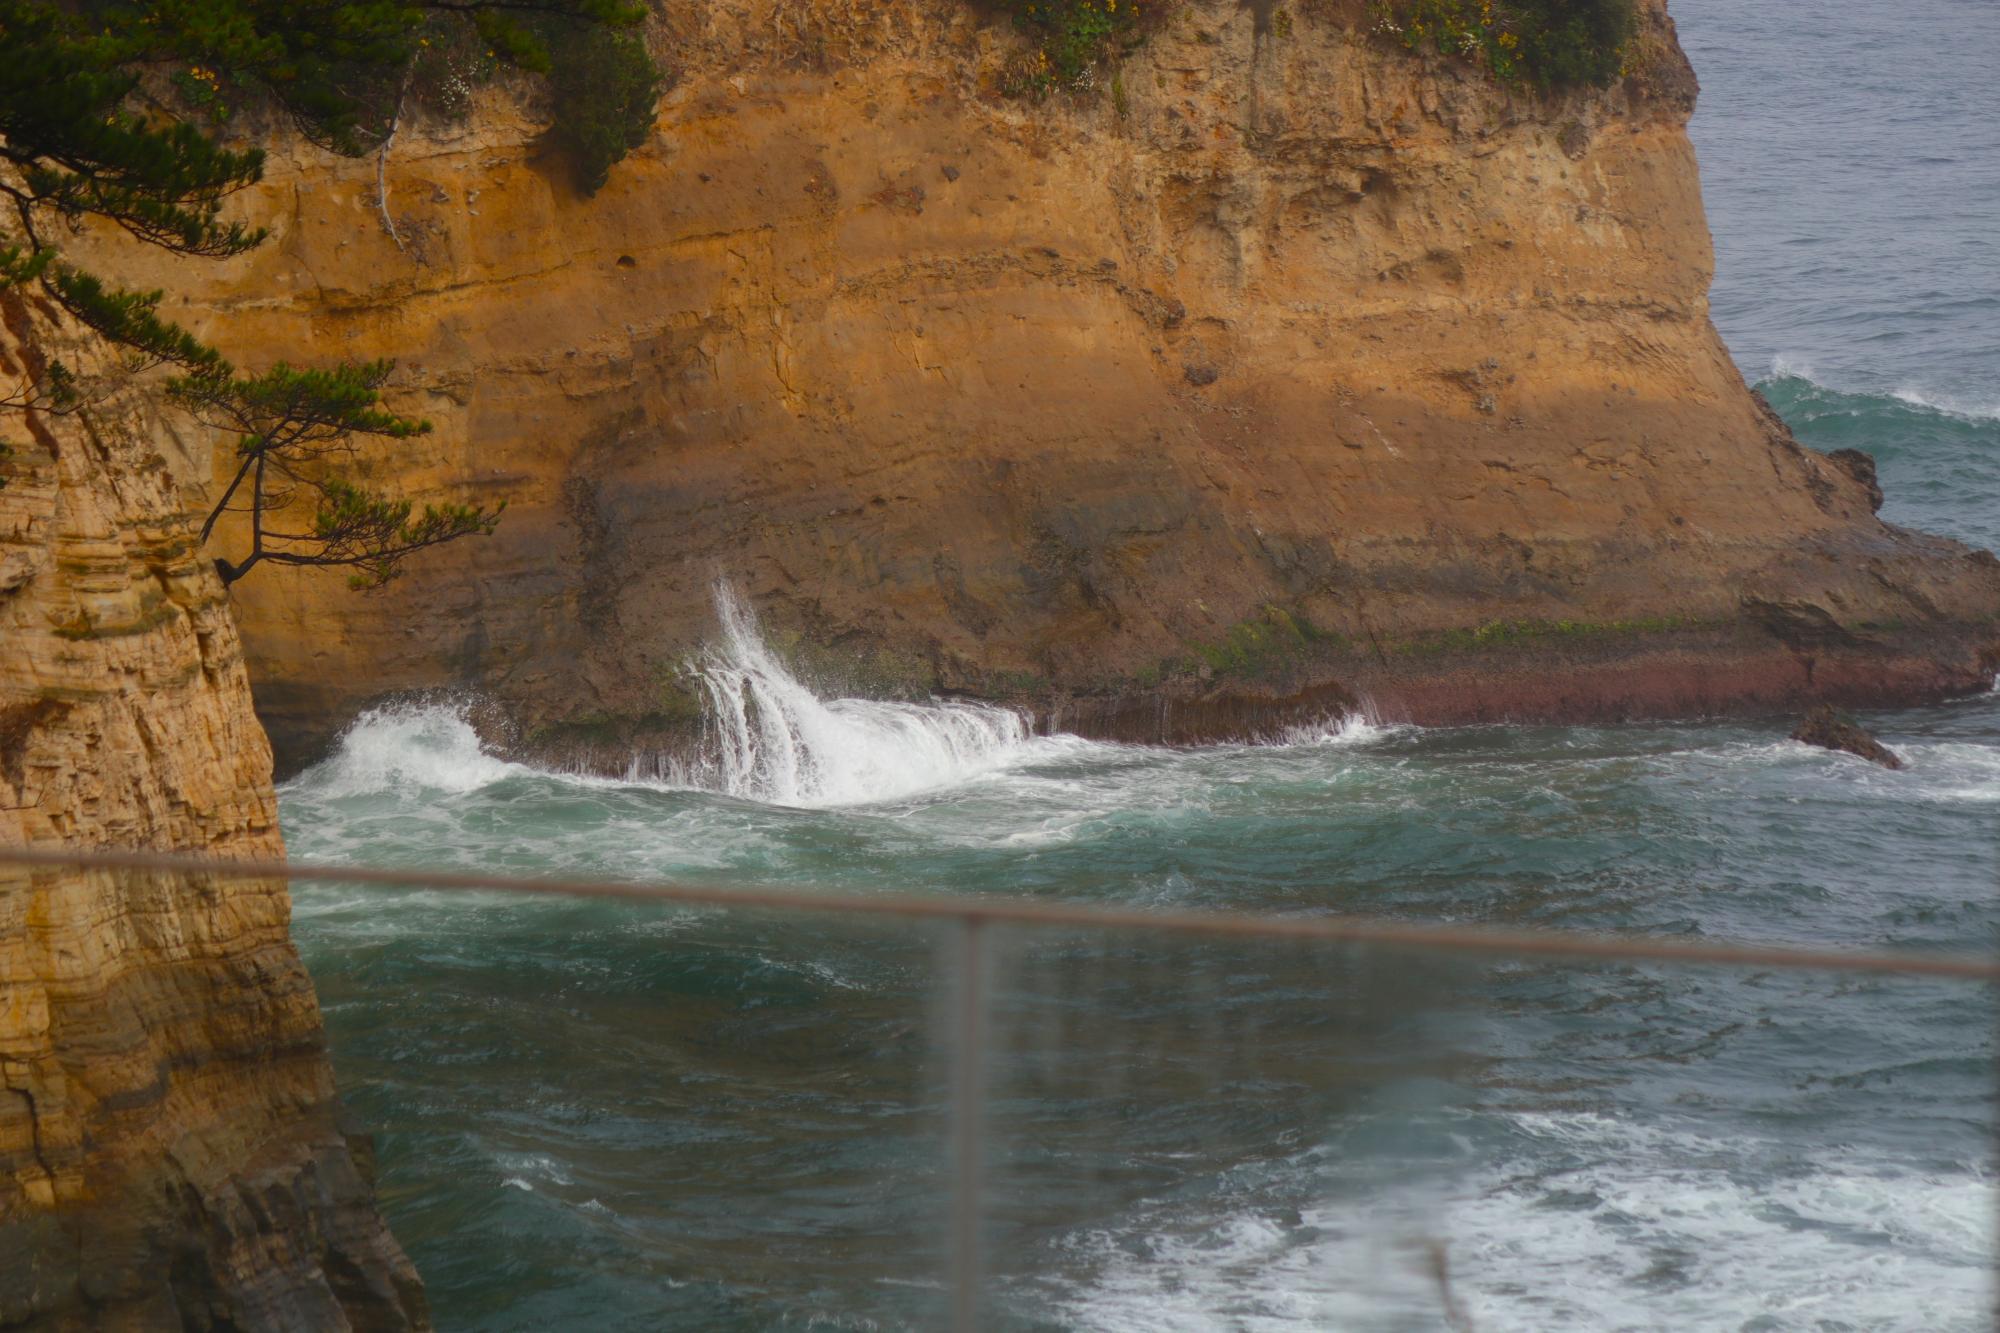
[0,0,660,586]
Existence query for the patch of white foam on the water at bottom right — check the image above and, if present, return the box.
[1056,1115,1994,1333]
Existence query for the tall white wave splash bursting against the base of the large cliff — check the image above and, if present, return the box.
[652,584,1032,807]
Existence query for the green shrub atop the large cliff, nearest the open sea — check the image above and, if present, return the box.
[1370,0,1638,92]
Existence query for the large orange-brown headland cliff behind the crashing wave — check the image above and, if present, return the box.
[74,0,2000,759]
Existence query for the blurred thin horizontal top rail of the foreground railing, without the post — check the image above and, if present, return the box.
[0,849,2000,981]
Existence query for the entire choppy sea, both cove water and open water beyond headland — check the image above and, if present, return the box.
[282,0,2000,1333]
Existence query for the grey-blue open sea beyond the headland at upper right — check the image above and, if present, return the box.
[1670,0,2000,546]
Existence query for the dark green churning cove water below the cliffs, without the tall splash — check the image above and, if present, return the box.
[284,688,2000,1333]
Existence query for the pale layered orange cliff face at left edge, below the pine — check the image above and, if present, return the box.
[0,290,428,1329]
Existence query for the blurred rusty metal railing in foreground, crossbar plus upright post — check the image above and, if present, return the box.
[0,849,2000,1333]
